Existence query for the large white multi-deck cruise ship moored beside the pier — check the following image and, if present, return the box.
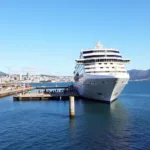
[74,41,130,103]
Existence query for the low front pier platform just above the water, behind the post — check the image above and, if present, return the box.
[14,92,79,101]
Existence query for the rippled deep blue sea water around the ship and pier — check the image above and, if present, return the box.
[0,81,150,150]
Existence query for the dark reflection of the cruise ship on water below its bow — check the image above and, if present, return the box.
[70,100,131,149]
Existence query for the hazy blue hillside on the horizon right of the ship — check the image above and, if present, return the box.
[128,69,150,80]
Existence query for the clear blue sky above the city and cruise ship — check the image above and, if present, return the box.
[0,0,150,75]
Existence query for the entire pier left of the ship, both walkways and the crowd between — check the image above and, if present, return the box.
[0,86,79,100]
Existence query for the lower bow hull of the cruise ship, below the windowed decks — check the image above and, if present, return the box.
[75,74,129,103]
